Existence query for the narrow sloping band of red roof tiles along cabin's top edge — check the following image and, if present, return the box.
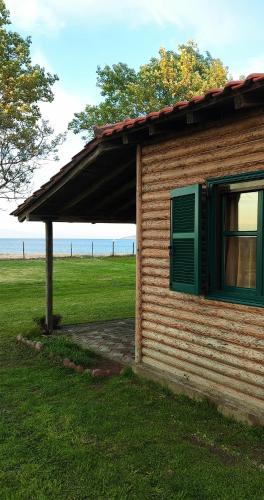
[11,73,264,216]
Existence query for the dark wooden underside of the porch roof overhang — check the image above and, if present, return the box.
[12,140,136,223]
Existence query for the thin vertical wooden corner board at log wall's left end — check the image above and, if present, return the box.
[135,146,142,363]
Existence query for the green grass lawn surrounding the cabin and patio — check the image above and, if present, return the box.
[0,257,264,500]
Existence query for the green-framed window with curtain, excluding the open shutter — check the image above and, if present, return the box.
[208,172,264,305]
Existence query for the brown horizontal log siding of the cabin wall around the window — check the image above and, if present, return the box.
[142,115,264,411]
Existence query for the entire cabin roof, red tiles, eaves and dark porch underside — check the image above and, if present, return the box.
[12,74,264,223]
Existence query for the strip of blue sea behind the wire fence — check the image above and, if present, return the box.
[0,238,136,258]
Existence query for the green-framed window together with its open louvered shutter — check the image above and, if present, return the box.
[170,171,264,306]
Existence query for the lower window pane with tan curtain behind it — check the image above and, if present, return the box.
[224,236,257,288]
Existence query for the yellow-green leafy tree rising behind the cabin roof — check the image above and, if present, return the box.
[68,41,229,139]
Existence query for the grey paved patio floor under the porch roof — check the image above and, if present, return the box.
[63,319,135,365]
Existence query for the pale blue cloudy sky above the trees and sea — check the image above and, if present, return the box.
[0,0,264,238]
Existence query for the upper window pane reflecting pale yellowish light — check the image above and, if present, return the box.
[225,191,258,231]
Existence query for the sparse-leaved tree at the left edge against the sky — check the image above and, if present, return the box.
[0,0,63,199]
